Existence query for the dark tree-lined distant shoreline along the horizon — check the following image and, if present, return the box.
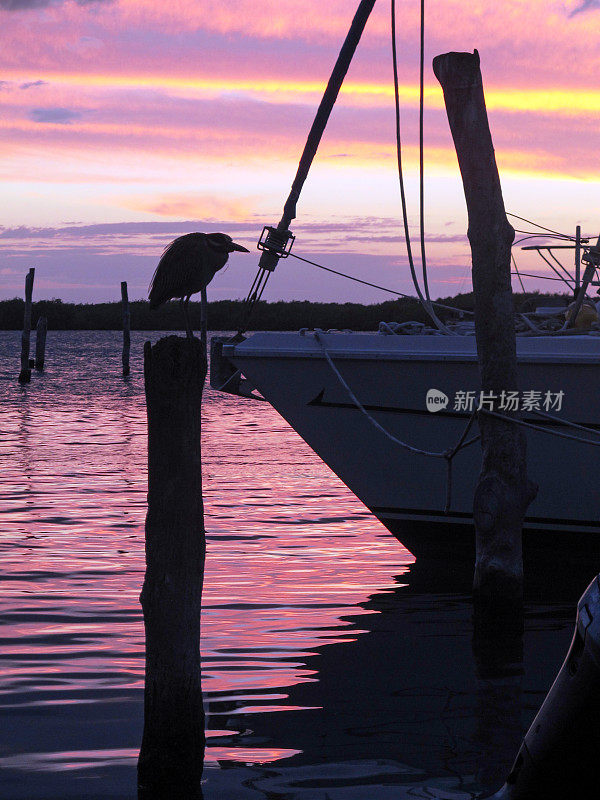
[0,292,571,331]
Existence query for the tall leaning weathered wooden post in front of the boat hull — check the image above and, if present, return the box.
[433,50,537,624]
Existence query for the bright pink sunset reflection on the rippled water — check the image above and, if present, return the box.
[0,333,413,769]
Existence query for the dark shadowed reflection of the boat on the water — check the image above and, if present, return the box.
[205,561,585,800]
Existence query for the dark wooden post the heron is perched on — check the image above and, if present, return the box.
[138,336,206,800]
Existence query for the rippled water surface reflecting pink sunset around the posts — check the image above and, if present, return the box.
[0,332,598,800]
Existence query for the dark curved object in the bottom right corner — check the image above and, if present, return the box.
[482,576,600,800]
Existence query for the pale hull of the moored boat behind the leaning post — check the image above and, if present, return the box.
[214,333,600,550]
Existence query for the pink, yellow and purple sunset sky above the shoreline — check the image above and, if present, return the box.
[0,0,600,302]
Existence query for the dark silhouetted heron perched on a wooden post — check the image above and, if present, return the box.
[148,233,249,345]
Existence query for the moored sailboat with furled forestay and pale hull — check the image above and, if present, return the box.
[211,0,600,554]
